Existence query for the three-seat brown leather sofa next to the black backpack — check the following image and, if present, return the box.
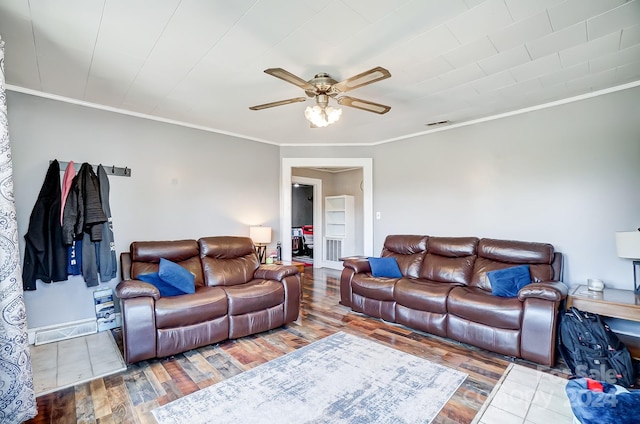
[340,235,567,366]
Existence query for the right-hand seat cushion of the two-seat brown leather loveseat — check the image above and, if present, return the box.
[224,280,284,315]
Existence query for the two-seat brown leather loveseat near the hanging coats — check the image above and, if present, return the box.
[116,237,301,364]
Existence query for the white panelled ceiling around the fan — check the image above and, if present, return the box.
[0,0,640,145]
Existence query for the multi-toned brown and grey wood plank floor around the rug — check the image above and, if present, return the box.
[28,268,563,424]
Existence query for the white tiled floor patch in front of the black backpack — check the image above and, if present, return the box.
[473,364,573,424]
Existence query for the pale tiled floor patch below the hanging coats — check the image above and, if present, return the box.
[30,331,127,396]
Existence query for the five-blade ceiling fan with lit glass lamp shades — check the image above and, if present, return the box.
[249,66,391,128]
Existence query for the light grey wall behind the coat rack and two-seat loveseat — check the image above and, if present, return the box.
[8,92,280,328]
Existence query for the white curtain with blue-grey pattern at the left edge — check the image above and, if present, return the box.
[0,38,38,423]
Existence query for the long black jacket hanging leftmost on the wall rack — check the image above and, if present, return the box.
[22,160,67,290]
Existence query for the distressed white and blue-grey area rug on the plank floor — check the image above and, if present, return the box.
[152,332,467,424]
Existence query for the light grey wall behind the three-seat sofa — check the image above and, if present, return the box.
[374,88,640,289]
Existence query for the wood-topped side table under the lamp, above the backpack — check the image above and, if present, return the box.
[567,285,640,358]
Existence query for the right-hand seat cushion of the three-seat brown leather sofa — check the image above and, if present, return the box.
[447,287,523,330]
